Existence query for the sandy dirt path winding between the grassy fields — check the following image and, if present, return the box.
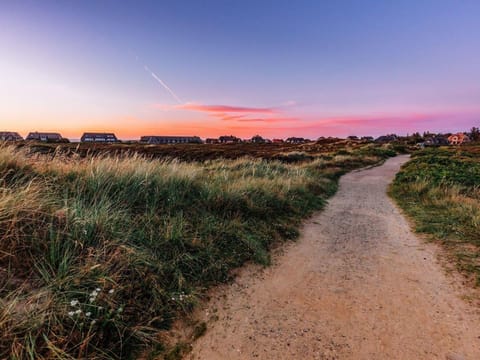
[188,156,480,360]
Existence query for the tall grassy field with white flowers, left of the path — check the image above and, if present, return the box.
[0,144,395,359]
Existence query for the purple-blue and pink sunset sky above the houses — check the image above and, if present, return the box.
[0,0,480,139]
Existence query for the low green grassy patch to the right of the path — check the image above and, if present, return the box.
[391,145,480,286]
